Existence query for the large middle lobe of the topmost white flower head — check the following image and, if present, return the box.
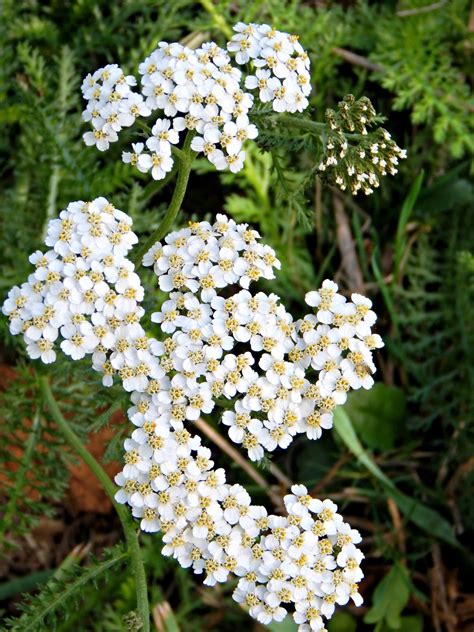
[138,42,258,172]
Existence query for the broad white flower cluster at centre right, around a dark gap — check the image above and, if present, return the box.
[144,220,382,460]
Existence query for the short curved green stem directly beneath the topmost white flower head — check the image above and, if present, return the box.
[132,131,196,265]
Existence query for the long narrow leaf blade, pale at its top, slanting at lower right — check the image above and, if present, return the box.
[334,407,461,548]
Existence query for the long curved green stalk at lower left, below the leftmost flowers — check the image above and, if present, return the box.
[39,376,150,632]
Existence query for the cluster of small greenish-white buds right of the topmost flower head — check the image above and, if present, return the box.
[319,94,407,195]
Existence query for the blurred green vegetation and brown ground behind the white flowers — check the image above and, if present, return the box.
[0,0,474,632]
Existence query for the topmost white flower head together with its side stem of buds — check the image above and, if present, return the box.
[82,22,405,194]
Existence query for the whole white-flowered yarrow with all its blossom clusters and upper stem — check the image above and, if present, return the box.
[3,23,402,632]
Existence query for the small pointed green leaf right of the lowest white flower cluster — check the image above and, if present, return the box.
[364,562,410,630]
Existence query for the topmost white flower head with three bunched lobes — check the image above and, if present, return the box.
[82,23,311,175]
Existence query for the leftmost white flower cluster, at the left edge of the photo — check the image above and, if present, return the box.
[3,197,148,382]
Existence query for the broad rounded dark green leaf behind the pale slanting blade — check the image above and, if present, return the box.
[344,384,406,450]
